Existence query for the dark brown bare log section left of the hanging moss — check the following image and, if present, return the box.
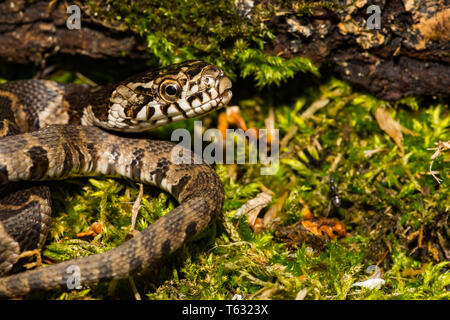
[0,0,147,63]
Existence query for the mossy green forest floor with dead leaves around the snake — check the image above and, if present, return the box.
[3,69,450,299]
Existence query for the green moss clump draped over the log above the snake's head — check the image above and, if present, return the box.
[81,0,320,86]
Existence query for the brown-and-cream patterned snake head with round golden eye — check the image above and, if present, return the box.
[103,61,232,132]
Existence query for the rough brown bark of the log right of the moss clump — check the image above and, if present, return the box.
[267,0,450,100]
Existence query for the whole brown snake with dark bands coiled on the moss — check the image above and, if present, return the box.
[0,60,232,298]
